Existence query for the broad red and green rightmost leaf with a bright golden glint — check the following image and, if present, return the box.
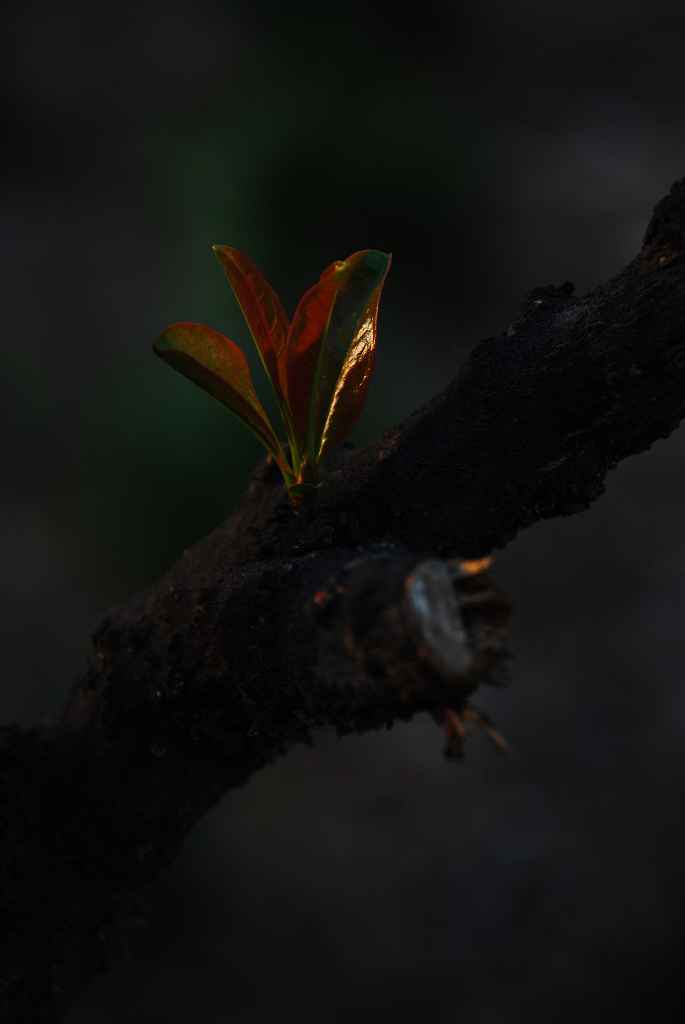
[285,249,390,463]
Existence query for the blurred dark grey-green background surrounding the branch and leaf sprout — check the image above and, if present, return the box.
[0,0,685,1024]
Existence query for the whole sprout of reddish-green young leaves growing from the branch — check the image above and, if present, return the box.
[155,246,390,504]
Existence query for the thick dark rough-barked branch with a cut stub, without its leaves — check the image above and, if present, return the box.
[0,179,685,1022]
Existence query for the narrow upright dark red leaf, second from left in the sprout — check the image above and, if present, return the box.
[212,246,288,399]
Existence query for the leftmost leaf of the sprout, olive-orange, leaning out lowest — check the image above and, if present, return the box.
[155,323,290,473]
